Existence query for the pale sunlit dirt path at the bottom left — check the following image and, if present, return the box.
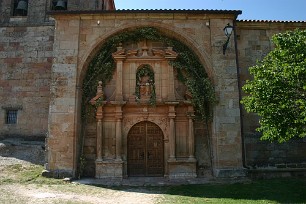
[0,184,161,204]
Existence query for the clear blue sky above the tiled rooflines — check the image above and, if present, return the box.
[115,0,306,21]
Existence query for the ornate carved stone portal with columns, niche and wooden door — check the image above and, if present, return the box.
[85,41,196,178]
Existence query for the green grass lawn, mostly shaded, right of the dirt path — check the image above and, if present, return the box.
[165,178,306,204]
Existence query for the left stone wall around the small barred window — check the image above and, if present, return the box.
[0,26,54,136]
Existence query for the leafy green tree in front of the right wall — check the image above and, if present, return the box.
[242,30,306,143]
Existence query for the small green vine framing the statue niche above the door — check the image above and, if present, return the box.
[135,64,156,105]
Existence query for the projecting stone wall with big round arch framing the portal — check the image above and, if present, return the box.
[49,11,242,176]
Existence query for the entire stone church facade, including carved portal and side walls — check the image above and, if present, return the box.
[0,0,306,179]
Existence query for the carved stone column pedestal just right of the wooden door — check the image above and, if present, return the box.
[168,159,197,179]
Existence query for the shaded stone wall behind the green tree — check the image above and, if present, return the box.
[237,21,306,168]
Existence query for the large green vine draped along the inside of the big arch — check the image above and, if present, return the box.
[82,27,216,121]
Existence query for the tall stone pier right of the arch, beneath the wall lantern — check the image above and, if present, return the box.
[210,19,243,177]
